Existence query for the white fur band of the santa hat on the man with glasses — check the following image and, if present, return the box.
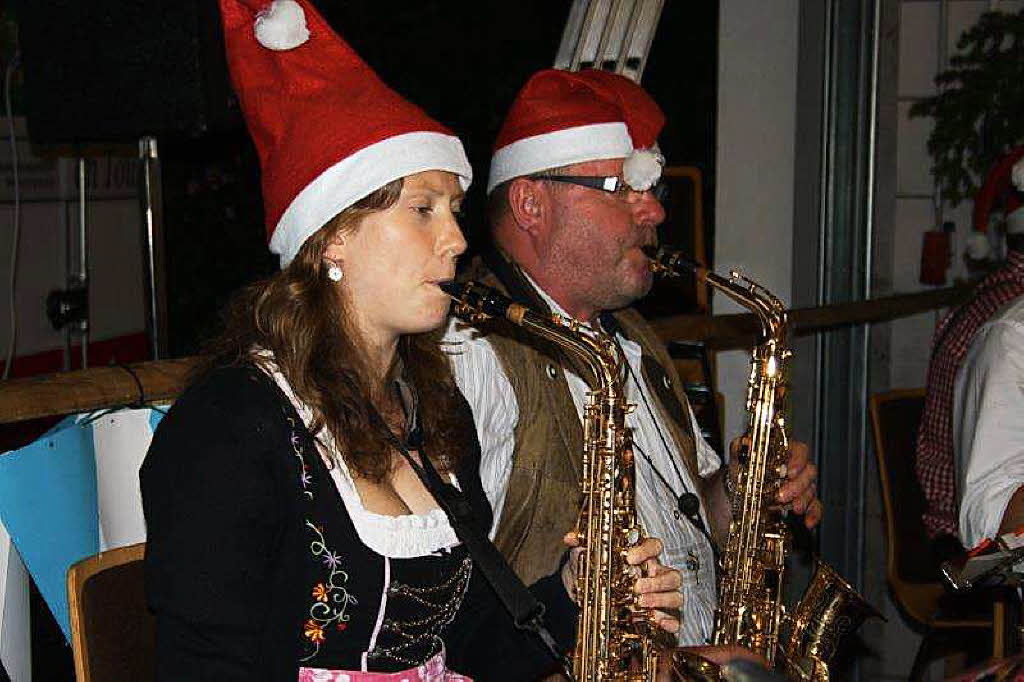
[487,123,633,195]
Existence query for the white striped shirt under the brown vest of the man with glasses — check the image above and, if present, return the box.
[444,280,721,645]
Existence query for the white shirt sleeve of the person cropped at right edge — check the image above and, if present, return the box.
[952,319,1024,547]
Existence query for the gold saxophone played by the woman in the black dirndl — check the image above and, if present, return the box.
[442,282,723,682]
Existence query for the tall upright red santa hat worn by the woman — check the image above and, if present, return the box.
[220,0,472,267]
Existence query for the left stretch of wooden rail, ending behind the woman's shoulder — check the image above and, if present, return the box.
[0,357,196,424]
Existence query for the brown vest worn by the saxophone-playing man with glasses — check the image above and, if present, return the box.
[468,258,699,585]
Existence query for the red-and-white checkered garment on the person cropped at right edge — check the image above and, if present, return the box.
[914,251,1024,537]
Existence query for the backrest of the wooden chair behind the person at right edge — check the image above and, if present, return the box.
[870,388,942,623]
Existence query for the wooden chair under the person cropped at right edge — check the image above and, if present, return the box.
[870,388,1019,680]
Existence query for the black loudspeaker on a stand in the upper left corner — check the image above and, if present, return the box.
[17,0,242,144]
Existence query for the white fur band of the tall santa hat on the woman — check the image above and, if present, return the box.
[270,132,473,268]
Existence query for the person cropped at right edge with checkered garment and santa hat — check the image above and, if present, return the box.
[914,147,1024,558]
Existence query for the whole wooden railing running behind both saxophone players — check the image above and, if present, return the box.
[0,286,971,424]
